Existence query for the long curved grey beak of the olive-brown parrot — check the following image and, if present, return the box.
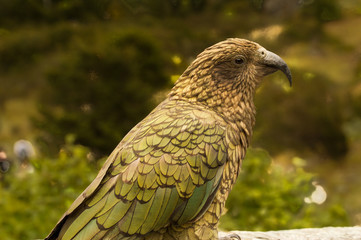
[259,49,292,86]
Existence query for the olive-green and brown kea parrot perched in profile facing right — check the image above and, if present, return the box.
[45,38,292,240]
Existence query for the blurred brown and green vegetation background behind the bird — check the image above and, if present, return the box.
[0,0,361,239]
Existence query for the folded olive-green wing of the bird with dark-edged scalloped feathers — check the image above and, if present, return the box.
[48,100,227,239]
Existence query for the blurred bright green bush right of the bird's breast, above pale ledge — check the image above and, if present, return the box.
[220,149,348,231]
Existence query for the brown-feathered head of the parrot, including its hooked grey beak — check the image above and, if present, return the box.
[170,38,292,105]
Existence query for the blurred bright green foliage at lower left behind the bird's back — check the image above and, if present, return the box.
[0,135,101,240]
